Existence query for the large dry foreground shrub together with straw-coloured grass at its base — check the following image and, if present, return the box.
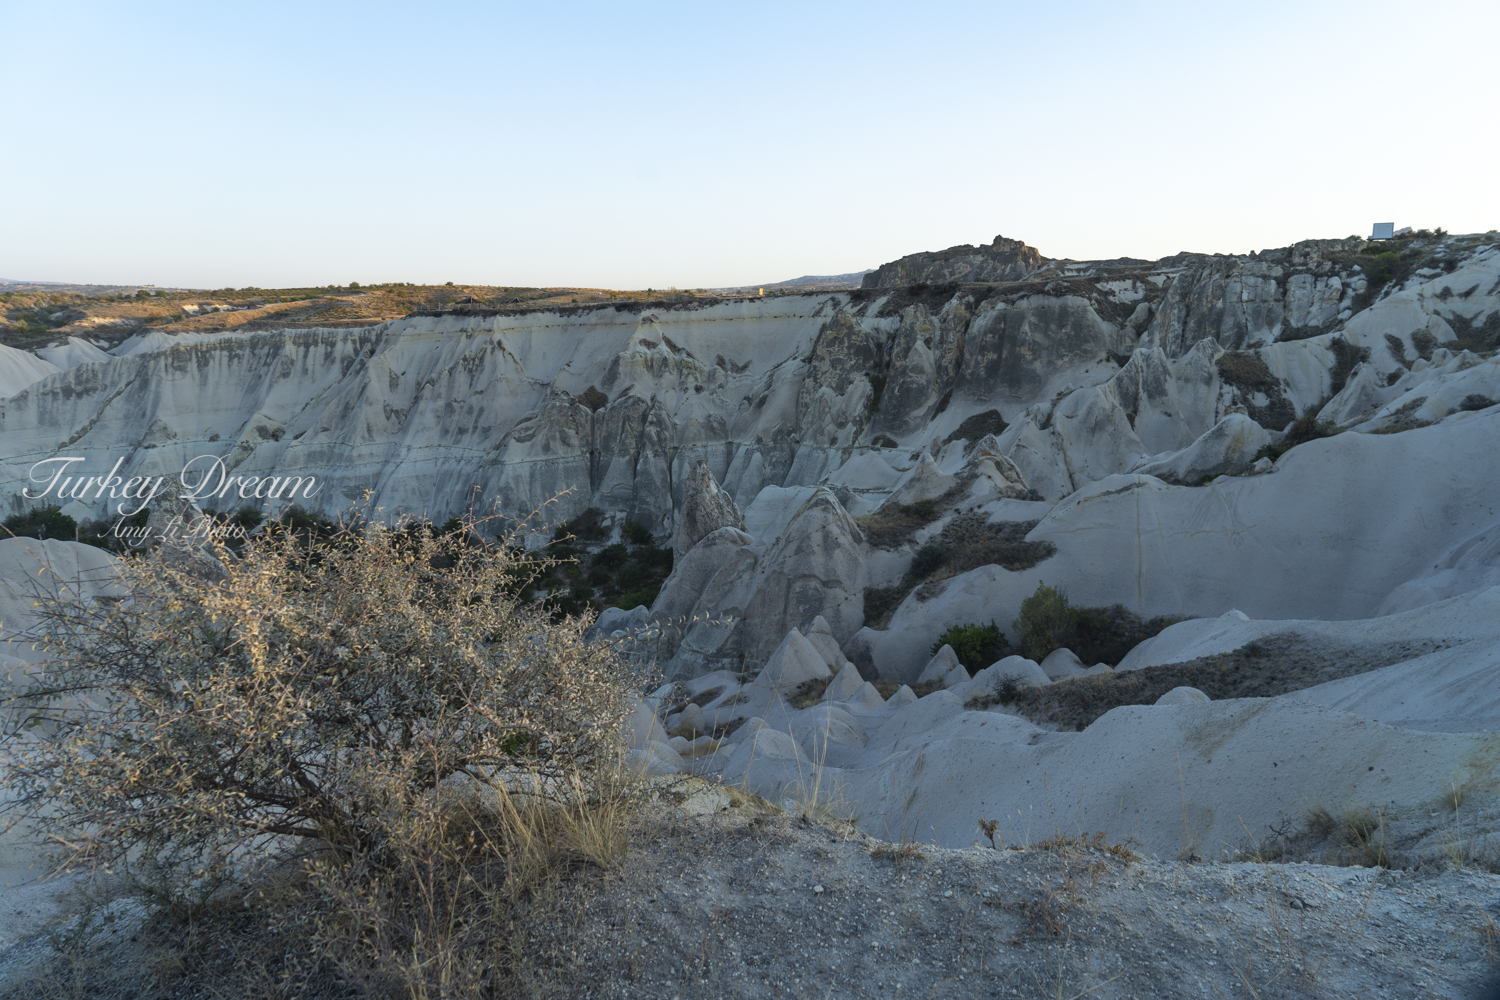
[5,512,639,997]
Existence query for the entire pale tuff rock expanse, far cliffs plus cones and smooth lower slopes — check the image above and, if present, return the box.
[0,224,1500,875]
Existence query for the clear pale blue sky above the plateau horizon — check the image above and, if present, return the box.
[0,0,1500,288]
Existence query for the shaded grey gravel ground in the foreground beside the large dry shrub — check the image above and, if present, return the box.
[0,780,1500,1000]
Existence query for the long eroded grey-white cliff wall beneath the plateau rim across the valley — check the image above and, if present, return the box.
[0,240,1496,524]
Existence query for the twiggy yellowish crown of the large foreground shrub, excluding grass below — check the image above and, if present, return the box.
[8,515,626,867]
